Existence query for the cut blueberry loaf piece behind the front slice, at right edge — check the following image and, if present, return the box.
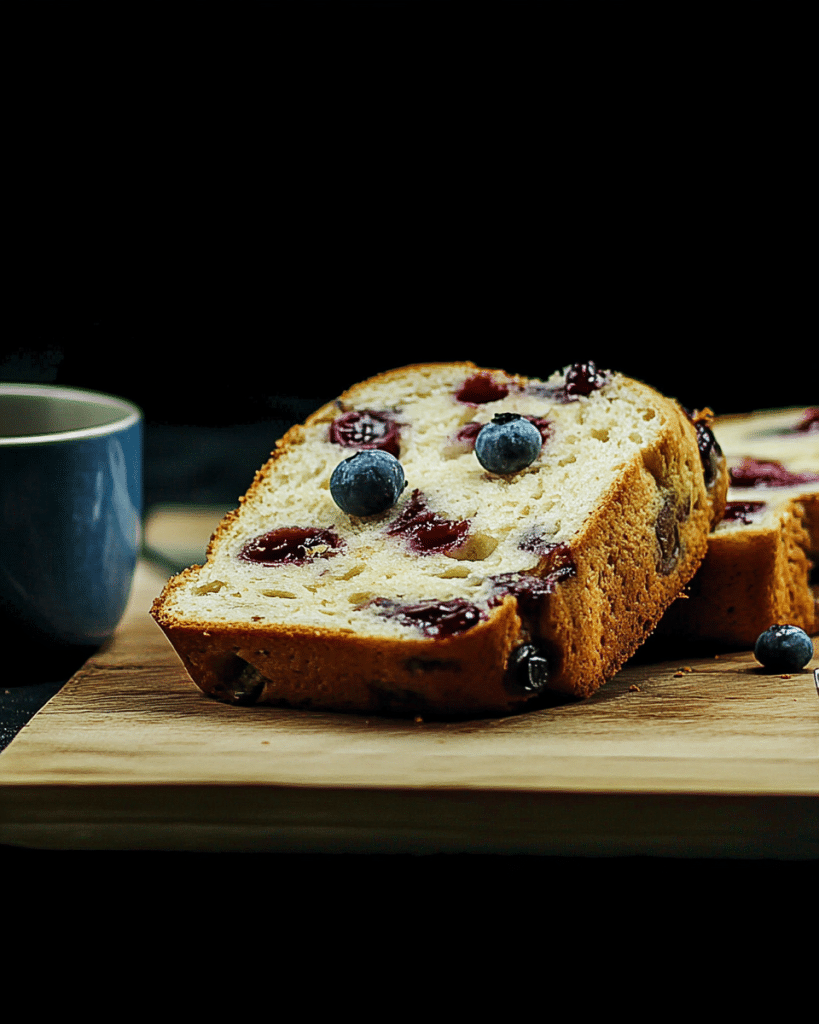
[657,409,819,648]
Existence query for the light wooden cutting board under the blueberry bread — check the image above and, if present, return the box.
[0,564,819,858]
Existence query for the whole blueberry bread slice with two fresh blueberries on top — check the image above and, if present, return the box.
[152,362,726,715]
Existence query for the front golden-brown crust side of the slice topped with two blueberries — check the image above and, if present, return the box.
[160,598,521,715]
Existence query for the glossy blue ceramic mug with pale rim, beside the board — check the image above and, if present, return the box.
[0,383,142,683]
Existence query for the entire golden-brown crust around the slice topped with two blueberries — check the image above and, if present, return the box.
[152,362,725,716]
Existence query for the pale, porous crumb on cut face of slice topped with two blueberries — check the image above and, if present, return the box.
[159,365,679,637]
